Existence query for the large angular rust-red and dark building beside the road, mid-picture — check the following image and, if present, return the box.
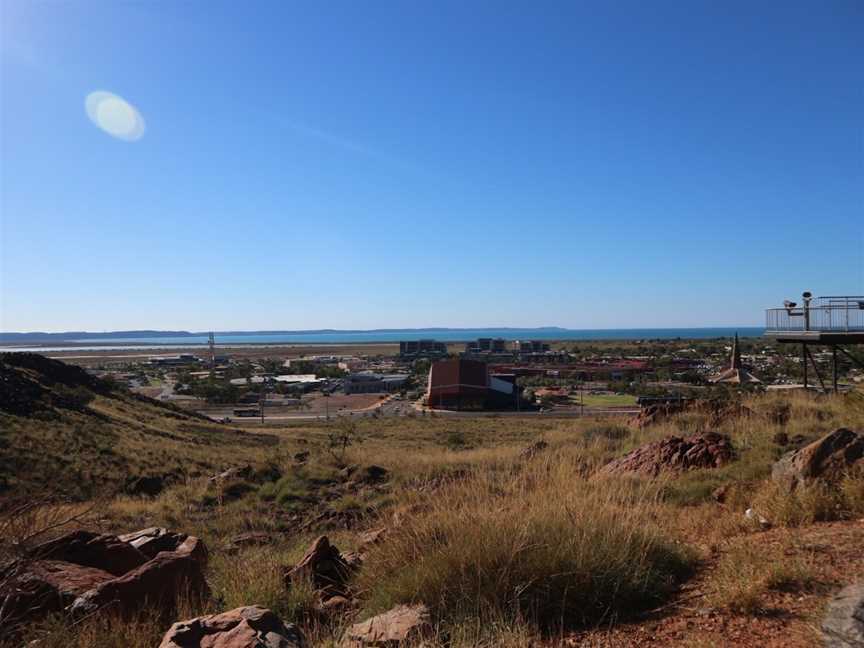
[426,358,518,410]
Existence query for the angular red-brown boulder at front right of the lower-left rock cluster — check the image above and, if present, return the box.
[72,552,210,616]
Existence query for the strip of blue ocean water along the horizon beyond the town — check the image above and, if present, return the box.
[0,326,765,351]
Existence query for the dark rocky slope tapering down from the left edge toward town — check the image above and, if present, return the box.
[0,353,278,499]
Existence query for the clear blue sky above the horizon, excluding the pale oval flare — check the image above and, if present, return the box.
[0,0,864,331]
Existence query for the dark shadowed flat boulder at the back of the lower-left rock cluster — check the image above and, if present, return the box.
[28,529,148,576]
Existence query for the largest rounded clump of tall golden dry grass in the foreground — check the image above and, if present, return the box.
[358,457,689,628]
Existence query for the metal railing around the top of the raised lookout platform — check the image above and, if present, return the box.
[765,296,864,333]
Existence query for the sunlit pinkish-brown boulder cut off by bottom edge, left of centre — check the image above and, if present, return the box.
[159,606,307,648]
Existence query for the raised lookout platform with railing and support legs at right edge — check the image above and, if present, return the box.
[765,292,864,392]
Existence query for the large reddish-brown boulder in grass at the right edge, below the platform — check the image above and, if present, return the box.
[771,428,864,490]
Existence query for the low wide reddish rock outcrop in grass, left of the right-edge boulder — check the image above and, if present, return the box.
[598,432,735,477]
